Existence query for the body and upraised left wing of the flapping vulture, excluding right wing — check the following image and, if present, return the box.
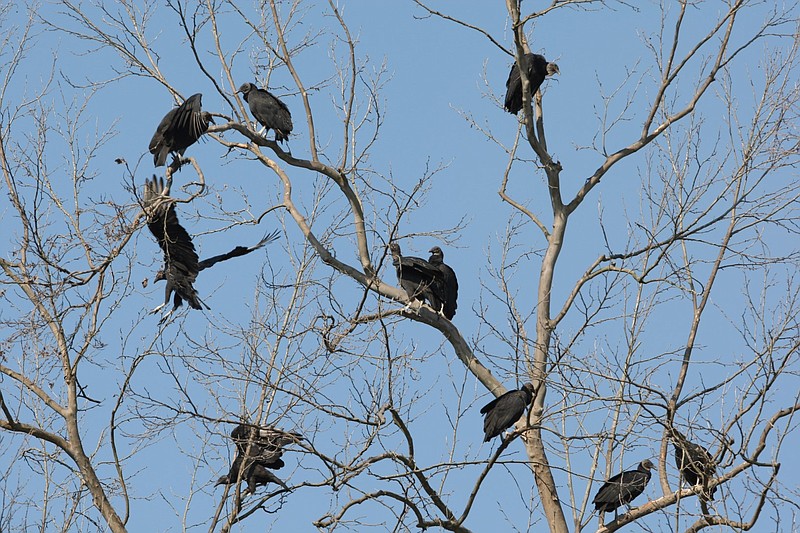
[142,176,209,320]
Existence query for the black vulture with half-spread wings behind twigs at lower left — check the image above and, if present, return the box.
[216,424,303,493]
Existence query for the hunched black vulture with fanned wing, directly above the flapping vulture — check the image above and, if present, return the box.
[150,93,214,167]
